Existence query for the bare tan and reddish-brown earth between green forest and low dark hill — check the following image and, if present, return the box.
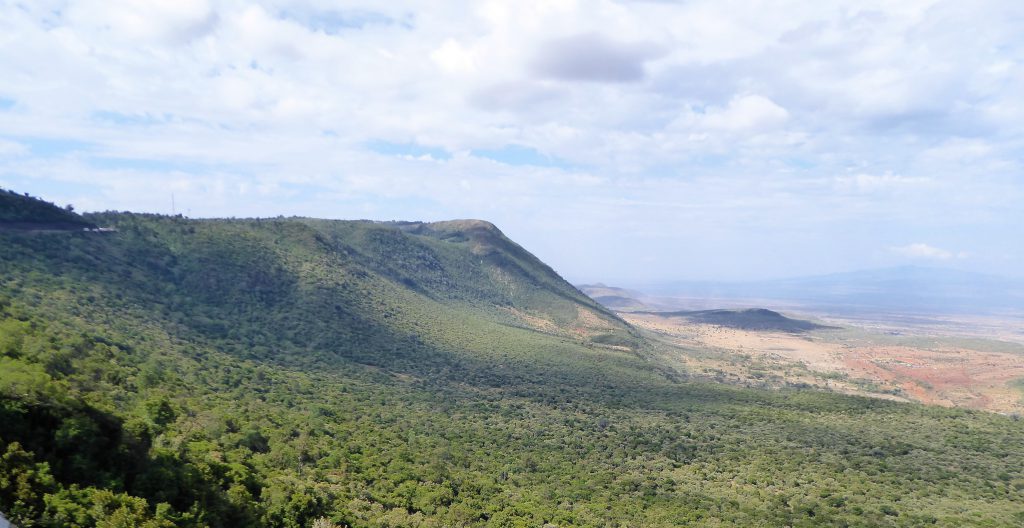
[621,313,1024,413]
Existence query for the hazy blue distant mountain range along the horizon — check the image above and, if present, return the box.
[581,266,1024,315]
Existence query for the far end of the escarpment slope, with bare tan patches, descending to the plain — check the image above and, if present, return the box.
[302,216,630,343]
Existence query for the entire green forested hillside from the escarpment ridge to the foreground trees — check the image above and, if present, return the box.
[0,194,1024,527]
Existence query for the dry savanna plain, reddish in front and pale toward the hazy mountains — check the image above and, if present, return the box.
[620,312,1024,414]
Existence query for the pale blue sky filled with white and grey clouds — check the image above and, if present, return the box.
[0,0,1024,283]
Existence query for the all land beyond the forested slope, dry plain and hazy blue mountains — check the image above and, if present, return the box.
[581,280,1024,413]
